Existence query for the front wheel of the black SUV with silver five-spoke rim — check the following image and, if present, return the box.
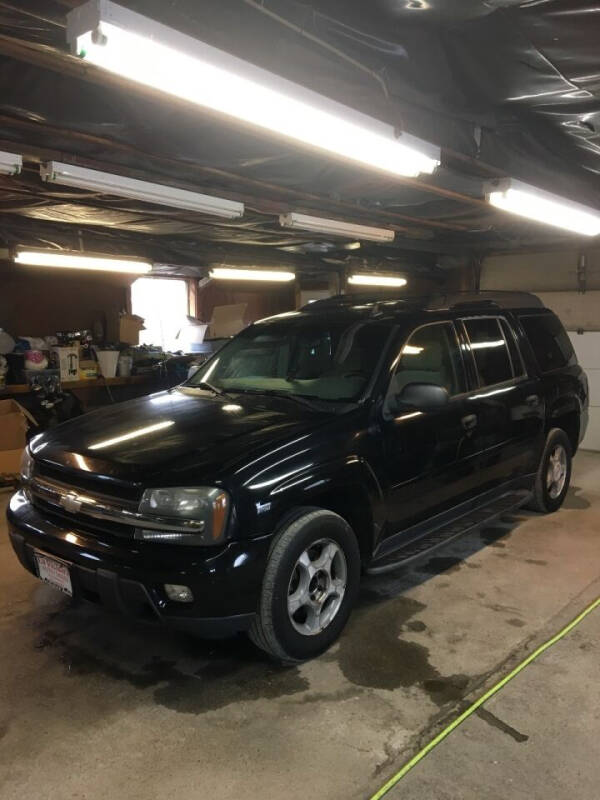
[249,508,360,664]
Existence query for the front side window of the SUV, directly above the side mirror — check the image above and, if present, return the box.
[386,322,465,406]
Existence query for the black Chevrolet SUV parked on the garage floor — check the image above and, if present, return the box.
[8,293,588,662]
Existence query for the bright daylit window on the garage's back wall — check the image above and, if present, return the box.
[131,278,188,352]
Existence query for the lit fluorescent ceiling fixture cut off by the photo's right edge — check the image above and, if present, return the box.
[488,178,600,236]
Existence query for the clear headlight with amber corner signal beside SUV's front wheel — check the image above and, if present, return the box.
[135,486,230,545]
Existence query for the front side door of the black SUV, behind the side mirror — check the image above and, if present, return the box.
[382,321,476,535]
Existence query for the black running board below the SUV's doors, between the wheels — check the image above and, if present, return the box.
[366,489,531,575]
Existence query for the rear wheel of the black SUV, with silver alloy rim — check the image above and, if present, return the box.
[527,428,571,514]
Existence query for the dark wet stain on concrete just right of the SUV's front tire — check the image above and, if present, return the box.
[338,597,471,705]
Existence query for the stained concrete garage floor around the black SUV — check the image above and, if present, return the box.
[0,452,600,800]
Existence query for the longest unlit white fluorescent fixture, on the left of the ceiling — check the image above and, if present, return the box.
[40,161,244,219]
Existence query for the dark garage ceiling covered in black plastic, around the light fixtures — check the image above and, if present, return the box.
[0,0,600,274]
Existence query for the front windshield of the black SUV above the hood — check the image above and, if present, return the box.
[187,316,390,402]
